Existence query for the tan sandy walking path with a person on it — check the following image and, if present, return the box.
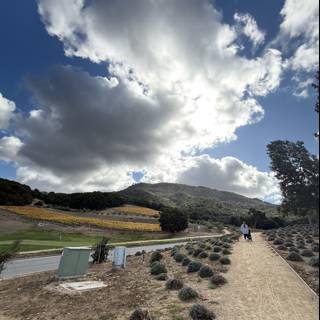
[212,234,319,320]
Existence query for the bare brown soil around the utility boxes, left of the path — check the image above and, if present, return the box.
[0,253,222,320]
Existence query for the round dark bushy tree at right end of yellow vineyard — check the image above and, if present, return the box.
[159,208,188,233]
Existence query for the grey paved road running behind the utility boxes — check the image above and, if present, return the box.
[1,243,188,279]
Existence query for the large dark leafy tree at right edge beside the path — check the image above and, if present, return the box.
[267,140,319,221]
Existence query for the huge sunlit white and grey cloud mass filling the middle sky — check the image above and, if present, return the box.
[0,0,282,200]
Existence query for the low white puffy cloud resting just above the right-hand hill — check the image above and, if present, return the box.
[143,154,280,202]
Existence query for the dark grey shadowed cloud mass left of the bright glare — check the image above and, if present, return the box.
[16,67,179,173]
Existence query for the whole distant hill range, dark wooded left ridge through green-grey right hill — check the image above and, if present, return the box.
[0,178,277,221]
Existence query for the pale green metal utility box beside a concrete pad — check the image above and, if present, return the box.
[57,247,91,278]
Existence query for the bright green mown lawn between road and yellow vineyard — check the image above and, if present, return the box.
[0,229,148,252]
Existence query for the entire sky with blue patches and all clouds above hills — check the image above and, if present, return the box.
[0,0,319,203]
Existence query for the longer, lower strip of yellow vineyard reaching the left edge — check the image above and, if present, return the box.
[0,206,161,232]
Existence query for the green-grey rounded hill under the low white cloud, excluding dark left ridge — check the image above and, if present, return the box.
[118,183,277,217]
